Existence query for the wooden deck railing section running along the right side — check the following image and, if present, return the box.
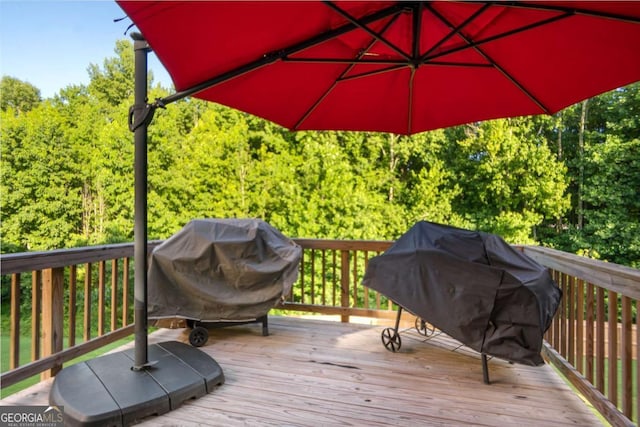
[522,246,640,425]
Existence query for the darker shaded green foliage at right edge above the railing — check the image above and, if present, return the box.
[539,83,640,268]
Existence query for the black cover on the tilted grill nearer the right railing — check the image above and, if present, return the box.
[363,221,562,365]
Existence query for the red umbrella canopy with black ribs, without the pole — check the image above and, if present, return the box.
[118,0,640,134]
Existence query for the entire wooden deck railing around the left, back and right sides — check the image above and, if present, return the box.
[0,239,640,425]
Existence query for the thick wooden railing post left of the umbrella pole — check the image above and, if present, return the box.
[41,267,64,380]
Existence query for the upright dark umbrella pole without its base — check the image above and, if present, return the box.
[129,33,153,371]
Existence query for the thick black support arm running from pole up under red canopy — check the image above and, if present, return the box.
[156,3,405,105]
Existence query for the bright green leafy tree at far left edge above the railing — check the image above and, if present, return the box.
[0,103,81,250]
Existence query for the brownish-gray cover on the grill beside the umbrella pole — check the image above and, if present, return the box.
[148,219,302,322]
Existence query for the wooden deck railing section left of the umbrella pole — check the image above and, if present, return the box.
[0,242,159,389]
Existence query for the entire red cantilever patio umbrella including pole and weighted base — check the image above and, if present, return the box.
[50,0,640,425]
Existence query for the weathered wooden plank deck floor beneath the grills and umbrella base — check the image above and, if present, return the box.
[0,316,602,427]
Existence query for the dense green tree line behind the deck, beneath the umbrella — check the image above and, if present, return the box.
[0,40,640,267]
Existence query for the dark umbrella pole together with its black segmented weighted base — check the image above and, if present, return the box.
[49,33,224,426]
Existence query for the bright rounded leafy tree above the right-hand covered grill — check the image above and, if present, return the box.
[440,118,568,243]
